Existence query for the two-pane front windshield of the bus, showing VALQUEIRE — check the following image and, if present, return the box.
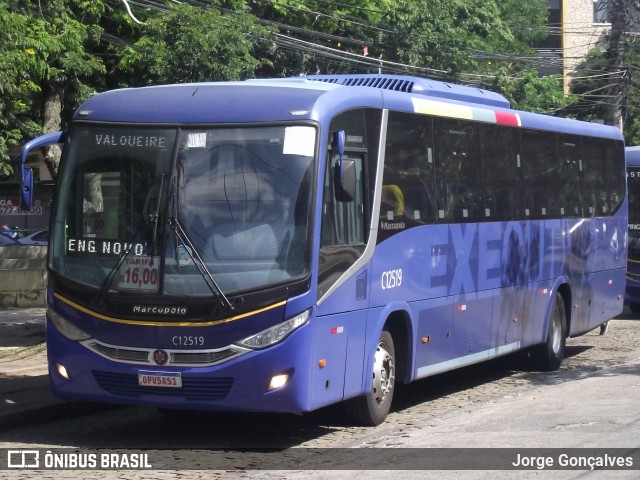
[50,125,316,295]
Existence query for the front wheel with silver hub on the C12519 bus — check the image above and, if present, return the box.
[345,330,396,427]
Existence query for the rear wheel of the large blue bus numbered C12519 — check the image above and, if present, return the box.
[531,294,567,371]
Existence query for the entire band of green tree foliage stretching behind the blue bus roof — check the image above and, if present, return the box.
[0,0,580,176]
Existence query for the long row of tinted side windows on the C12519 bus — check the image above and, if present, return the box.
[378,112,625,241]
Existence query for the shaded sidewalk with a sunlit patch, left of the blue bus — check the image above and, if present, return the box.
[0,308,86,430]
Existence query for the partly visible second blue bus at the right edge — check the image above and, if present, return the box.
[625,147,640,313]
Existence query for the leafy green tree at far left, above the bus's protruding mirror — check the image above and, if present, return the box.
[0,0,104,177]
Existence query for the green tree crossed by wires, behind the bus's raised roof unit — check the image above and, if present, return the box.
[251,0,547,80]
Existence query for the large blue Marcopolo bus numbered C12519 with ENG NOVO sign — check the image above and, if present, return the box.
[22,74,627,425]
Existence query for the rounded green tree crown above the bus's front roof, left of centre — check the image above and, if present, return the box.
[116,2,272,86]
